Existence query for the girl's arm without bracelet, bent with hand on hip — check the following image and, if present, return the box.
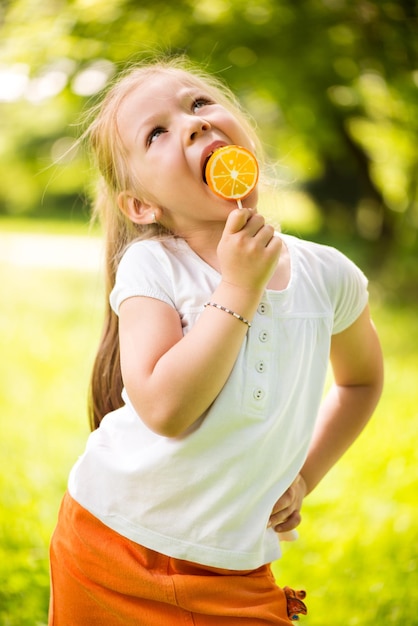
[270,307,383,532]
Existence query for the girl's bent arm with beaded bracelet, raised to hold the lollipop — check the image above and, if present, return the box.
[119,209,281,437]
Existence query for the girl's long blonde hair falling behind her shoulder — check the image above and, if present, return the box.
[87,57,263,429]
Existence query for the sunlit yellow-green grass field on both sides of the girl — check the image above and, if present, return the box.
[0,222,418,626]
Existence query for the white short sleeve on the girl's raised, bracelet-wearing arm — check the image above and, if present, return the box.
[109,241,174,315]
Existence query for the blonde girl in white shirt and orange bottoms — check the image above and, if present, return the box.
[49,56,382,626]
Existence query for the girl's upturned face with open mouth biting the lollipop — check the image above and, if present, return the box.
[117,73,257,235]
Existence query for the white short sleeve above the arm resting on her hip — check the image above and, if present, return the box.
[332,250,369,335]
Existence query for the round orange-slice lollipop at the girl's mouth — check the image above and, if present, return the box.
[205,146,258,208]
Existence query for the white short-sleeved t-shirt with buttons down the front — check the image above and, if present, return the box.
[69,235,368,570]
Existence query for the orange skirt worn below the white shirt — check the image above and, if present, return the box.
[49,494,306,626]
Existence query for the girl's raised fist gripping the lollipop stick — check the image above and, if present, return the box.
[217,208,282,291]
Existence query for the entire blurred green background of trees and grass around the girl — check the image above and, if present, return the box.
[0,0,418,626]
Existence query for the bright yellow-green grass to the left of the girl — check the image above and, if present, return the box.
[0,251,102,626]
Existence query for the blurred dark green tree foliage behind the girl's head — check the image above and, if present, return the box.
[0,0,418,297]
